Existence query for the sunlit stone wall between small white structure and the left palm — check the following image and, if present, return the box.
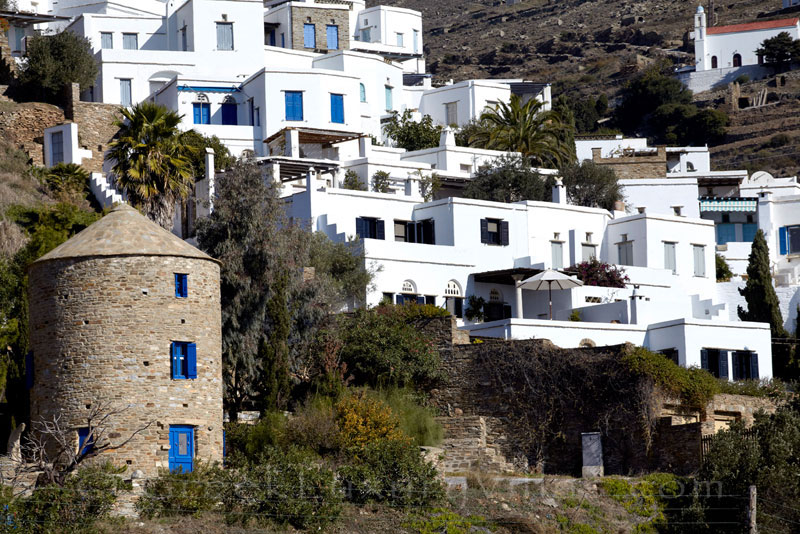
[64,84,122,172]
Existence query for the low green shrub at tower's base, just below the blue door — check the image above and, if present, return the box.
[136,463,224,518]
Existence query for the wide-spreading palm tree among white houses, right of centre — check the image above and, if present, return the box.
[470,95,574,167]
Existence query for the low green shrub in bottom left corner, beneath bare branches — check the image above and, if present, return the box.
[12,463,130,533]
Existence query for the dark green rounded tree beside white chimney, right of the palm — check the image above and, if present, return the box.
[559,161,623,211]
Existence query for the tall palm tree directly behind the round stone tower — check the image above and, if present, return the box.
[106,102,193,229]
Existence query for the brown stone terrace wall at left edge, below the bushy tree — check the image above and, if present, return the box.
[0,102,64,166]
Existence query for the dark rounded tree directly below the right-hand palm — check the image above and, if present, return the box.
[464,155,550,206]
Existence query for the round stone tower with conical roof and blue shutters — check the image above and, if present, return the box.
[29,204,223,476]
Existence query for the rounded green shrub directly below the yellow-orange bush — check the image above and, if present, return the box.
[339,440,445,506]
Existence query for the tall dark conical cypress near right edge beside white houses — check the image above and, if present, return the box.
[738,230,787,337]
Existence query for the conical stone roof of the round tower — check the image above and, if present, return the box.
[34,204,217,264]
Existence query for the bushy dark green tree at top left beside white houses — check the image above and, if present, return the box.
[20,31,98,102]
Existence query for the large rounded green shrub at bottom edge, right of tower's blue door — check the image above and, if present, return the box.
[221,447,342,530]
